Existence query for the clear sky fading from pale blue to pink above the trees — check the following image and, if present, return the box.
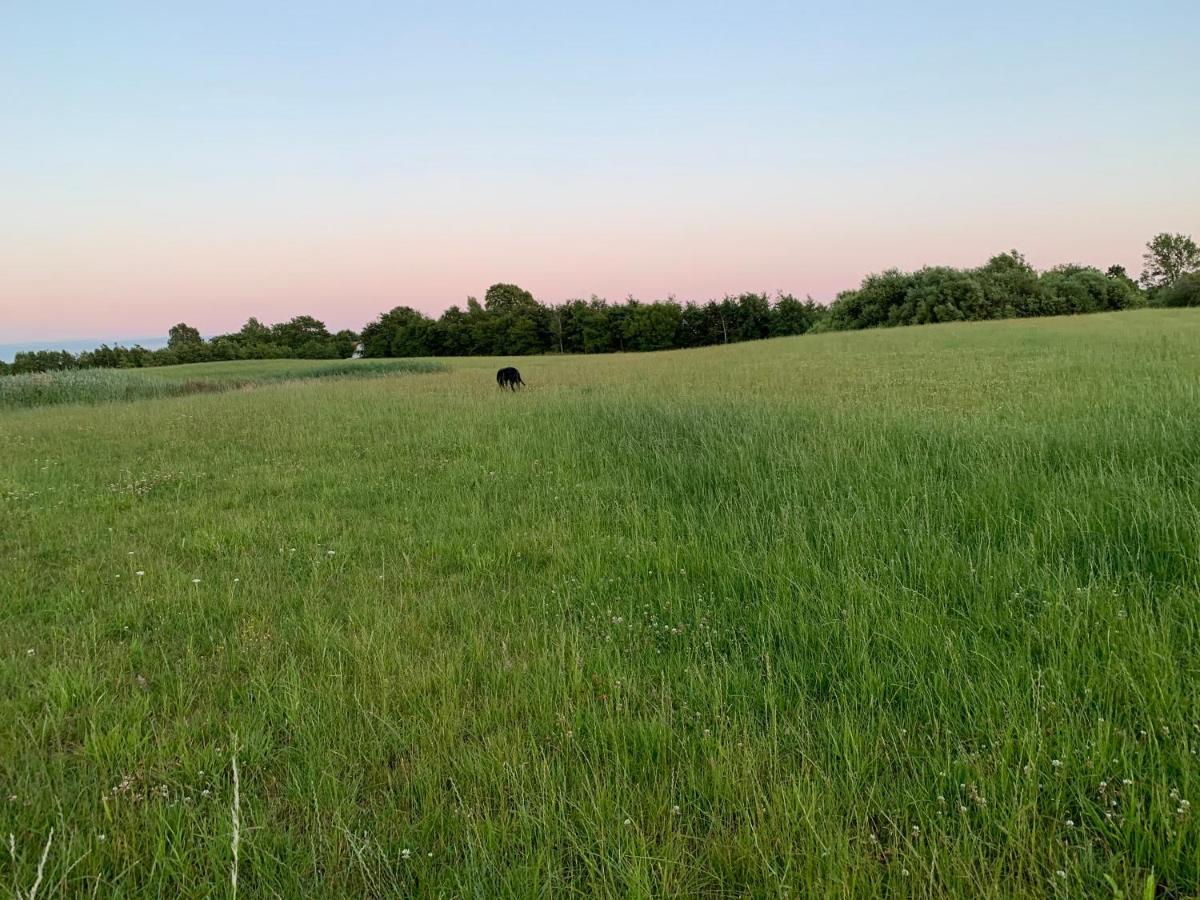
[0,0,1200,344]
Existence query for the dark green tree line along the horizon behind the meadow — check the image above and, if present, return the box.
[0,234,1200,374]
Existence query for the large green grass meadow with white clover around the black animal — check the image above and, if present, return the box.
[0,311,1200,898]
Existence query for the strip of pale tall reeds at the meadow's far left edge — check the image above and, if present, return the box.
[0,360,440,409]
